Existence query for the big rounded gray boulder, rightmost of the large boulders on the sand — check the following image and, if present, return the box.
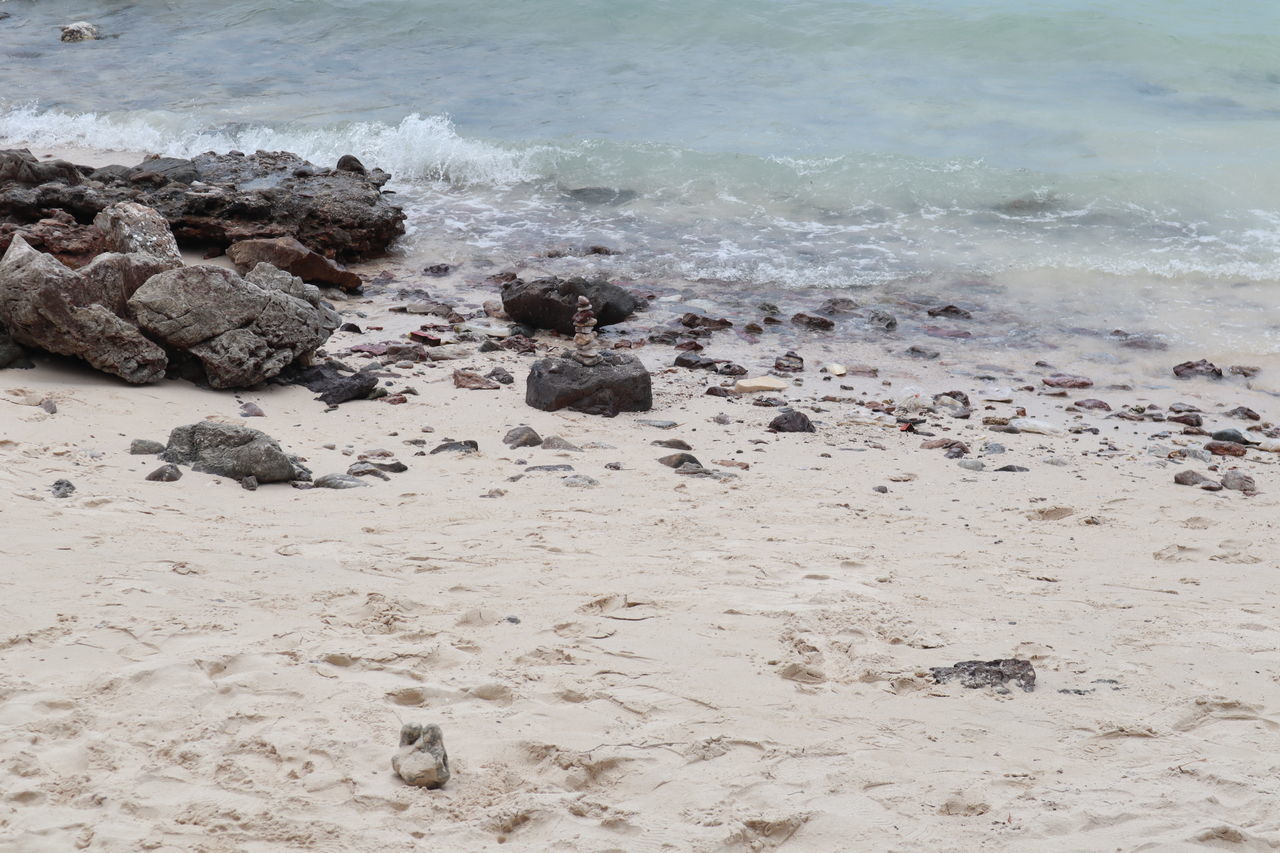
[129,264,339,388]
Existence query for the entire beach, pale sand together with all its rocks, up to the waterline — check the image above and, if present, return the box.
[0,146,1280,850]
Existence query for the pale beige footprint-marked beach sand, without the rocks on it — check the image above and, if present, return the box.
[0,144,1280,852]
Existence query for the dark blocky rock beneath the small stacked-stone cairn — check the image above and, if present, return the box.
[525,351,653,418]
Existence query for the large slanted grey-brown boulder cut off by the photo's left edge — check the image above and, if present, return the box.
[0,236,173,383]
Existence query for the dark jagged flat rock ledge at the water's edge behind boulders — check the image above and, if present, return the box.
[0,151,404,259]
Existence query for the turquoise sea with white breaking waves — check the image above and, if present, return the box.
[0,0,1280,326]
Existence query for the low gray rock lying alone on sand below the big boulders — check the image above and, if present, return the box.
[160,420,311,483]
